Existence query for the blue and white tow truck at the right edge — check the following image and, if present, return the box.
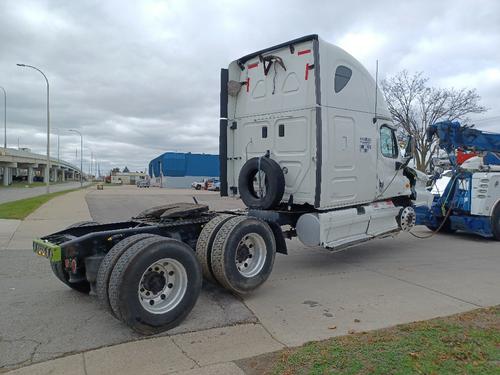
[416,121,500,240]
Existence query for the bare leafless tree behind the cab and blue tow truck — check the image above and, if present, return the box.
[381,70,487,172]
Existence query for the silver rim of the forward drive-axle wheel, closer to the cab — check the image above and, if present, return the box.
[234,233,267,277]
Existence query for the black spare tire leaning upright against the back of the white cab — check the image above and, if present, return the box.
[238,157,285,210]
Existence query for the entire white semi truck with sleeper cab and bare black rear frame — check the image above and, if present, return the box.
[33,35,432,334]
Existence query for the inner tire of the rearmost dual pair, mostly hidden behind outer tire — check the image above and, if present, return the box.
[96,233,154,315]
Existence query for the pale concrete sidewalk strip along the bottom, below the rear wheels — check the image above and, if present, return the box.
[4,324,283,375]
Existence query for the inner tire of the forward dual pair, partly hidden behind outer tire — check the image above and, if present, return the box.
[196,214,235,284]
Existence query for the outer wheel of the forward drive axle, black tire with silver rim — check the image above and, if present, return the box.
[211,216,276,294]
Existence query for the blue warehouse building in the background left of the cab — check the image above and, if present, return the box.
[149,152,220,188]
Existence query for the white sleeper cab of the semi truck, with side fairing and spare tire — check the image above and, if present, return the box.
[220,35,432,249]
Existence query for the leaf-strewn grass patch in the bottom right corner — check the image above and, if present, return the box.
[238,306,500,375]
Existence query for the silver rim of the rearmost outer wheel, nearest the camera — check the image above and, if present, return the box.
[137,258,187,314]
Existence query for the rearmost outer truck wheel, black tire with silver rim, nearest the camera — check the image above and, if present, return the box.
[109,236,203,335]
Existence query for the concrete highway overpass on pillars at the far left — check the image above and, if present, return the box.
[0,147,85,186]
